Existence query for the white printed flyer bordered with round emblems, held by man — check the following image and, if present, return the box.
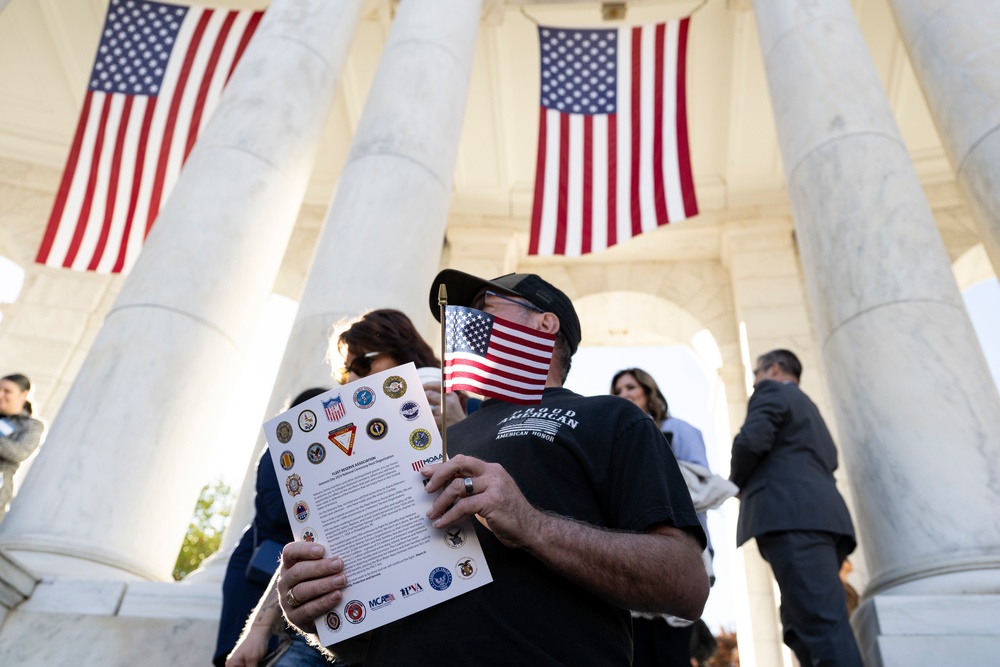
[264,363,493,646]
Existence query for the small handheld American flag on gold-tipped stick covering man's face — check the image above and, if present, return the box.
[444,306,556,405]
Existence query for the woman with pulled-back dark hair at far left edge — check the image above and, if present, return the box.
[0,374,45,521]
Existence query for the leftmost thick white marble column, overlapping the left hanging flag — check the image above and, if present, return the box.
[0,0,362,579]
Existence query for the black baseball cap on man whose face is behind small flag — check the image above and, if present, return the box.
[430,269,580,354]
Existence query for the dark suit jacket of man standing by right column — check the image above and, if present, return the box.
[730,380,854,550]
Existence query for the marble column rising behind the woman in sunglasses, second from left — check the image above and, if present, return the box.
[223,0,482,560]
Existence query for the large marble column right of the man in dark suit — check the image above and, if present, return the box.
[754,0,1000,664]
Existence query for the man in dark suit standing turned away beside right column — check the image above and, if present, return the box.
[730,350,863,667]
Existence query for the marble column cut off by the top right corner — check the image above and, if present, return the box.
[889,0,1000,274]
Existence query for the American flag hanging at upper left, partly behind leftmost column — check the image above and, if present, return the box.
[36,0,262,273]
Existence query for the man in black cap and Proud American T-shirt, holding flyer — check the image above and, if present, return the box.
[278,270,709,665]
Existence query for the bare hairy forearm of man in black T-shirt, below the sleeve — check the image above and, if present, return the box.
[523,513,709,619]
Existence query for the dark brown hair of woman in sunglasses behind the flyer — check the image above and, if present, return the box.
[337,308,441,368]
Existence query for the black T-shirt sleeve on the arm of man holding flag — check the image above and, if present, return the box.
[608,415,707,549]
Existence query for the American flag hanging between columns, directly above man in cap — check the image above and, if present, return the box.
[528,18,698,255]
